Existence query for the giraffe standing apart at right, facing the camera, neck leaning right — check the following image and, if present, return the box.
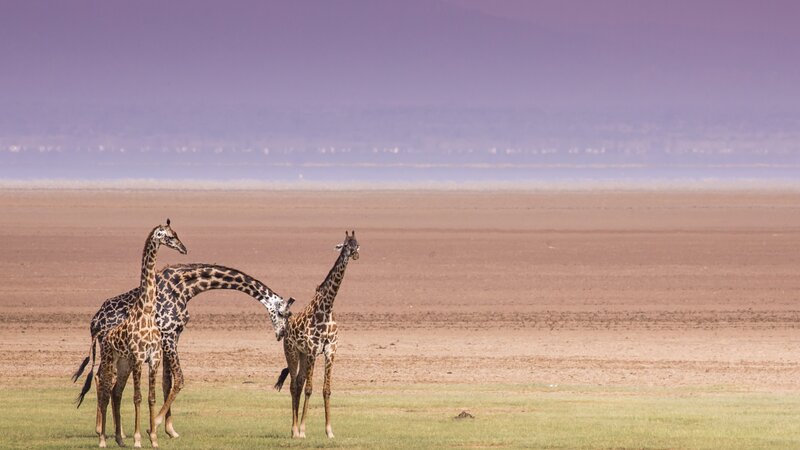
[275,231,359,438]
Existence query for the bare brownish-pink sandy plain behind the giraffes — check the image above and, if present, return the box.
[0,189,800,393]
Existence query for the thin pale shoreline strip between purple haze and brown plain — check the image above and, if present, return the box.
[0,178,800,192]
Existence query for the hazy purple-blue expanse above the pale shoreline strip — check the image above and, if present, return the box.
[0,0,800,180]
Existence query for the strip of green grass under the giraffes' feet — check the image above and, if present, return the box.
[0,383,800,449]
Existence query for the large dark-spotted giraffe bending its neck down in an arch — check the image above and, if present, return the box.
[72,264,294,439]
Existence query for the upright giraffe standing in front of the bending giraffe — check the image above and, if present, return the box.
[97,219,186,448]
